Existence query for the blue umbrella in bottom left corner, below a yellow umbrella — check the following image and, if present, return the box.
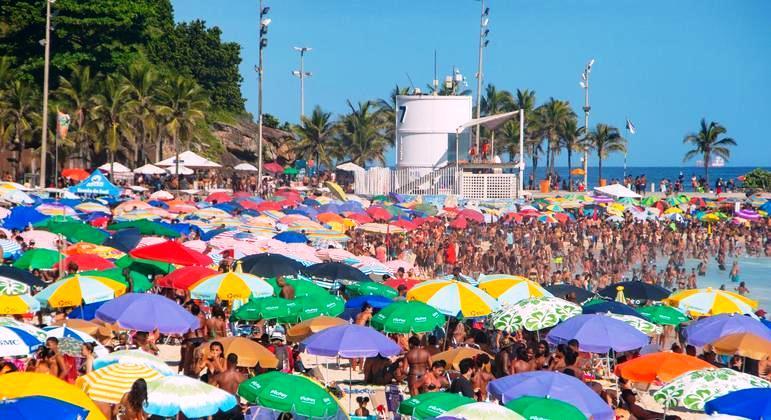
[0,395,88,420]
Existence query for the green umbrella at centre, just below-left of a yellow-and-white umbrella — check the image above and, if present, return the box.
[372,300,446,334]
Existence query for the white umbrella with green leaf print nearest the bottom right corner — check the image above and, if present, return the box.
[653,368,771,411]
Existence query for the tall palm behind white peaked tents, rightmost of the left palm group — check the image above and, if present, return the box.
[157,76,209,177]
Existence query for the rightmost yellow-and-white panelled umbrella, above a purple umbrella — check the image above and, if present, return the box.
[664,287,758,316]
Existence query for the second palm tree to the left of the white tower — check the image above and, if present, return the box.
[292,105,336,166]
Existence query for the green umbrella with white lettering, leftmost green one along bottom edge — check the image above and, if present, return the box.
[238,372,345,419]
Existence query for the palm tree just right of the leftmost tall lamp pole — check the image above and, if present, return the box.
[54,66,102,167]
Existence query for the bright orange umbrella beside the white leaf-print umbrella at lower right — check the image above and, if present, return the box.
[615,352,714,383]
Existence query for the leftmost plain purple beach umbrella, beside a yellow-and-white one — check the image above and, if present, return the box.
[96,293,200,334]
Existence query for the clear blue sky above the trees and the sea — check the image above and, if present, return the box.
[173,0,771,166]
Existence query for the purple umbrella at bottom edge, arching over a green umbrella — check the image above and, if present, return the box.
[487,371,615,420]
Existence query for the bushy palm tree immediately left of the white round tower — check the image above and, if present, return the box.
[338,101,389,167]
